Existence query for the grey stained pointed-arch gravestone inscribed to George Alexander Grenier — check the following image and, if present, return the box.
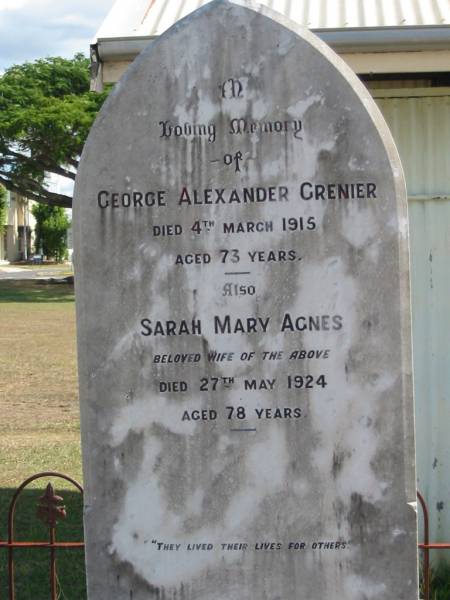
[74,0,417,600]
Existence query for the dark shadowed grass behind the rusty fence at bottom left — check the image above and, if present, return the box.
[0,488,86,600]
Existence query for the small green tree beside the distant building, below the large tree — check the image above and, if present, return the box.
[31,204,70,261]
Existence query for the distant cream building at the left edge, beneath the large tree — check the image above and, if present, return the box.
[0,192,36,262]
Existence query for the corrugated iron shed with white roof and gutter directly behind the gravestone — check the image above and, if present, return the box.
[91,0,450,541]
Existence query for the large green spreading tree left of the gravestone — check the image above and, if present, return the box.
[0,54,108,207]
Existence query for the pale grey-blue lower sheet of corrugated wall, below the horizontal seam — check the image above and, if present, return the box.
[410,200,450,541]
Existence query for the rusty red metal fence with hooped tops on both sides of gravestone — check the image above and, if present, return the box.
[0,471,450,600]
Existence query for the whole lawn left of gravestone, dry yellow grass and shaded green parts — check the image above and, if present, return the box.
[0,281,86,600]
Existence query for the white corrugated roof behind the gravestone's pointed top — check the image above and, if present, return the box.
[96,0,450,39]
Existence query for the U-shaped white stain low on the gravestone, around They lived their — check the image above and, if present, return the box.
[110,420,289,586]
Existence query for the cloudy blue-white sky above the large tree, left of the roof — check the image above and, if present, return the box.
[0,0,114,72]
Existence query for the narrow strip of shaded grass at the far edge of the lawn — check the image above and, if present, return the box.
[0,280,74,303]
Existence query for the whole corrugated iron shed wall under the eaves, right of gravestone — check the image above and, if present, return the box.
[374,88,450,541]
